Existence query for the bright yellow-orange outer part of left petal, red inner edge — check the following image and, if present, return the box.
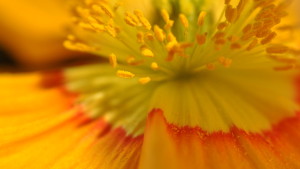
[0,74,142,169]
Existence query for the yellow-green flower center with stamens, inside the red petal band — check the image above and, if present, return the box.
[64,0,297,133]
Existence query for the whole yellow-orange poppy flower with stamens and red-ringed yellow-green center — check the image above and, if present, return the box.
[0,0,300,169]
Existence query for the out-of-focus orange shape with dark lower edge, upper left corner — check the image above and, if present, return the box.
[0,0,96,71]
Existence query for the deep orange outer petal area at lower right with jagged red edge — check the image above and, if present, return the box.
[139,110,300,169]
